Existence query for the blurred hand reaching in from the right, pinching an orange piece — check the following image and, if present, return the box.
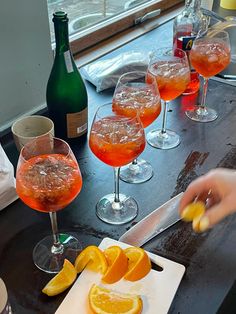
[179,168,236,232]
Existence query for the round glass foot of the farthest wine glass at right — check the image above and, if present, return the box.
[185,107,218,122]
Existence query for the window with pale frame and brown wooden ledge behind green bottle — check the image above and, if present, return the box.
[48,0,183,53]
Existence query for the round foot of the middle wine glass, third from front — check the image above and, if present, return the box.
[120,159,153,183]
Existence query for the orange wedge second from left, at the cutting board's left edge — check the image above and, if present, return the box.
[75,245,108,274]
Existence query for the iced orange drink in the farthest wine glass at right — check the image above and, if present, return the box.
[190,38,230,78]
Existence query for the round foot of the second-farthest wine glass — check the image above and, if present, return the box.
[146,130,180,149]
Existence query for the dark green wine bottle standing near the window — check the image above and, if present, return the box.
[46,12,88,139]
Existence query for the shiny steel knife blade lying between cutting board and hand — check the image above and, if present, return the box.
[119,192,183,246]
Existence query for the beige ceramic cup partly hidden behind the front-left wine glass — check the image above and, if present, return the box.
[11,115,54,151]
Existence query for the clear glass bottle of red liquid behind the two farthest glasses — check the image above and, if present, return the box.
[173,0,206,95]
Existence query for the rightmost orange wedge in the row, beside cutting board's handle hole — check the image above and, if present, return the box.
[124,246,151,281]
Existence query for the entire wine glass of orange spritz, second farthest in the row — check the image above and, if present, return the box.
[146,48,190,149]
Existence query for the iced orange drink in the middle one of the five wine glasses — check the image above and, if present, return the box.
[112,84,161,128]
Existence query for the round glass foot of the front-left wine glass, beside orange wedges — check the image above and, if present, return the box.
[33,233,82,273]
